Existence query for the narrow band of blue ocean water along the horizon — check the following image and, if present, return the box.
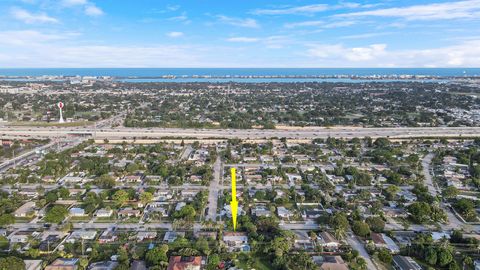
[0,68,480,82]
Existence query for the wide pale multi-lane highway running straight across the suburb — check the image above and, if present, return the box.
[0,125,480,140]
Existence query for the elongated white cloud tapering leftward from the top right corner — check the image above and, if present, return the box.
[336,0,480,21]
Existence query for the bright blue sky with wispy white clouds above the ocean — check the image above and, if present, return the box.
[0,0,480,68]
